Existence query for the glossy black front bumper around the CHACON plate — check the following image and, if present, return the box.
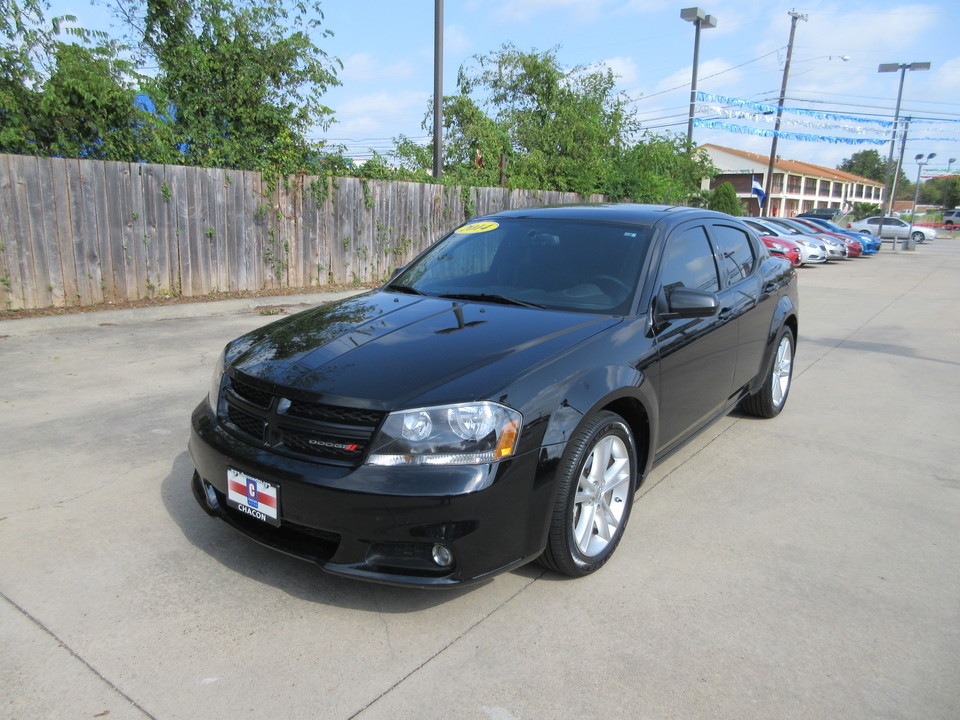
[189,402,556,587]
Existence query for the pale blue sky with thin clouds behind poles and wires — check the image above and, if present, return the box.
[53,0,960,178]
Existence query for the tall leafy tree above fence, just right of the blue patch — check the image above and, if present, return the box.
[133,0,340,174]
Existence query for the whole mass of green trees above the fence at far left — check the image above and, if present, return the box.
[0,0,346,173]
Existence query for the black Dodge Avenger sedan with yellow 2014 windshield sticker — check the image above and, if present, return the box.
[190,205,798,587]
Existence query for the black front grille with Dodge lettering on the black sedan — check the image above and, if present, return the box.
[221,376,386,466]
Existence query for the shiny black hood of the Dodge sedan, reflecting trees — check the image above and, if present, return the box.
[226,291,621,410]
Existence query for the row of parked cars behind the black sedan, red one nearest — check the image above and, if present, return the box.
[746,217,880,267]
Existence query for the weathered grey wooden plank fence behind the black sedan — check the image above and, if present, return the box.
[0,155,603,309]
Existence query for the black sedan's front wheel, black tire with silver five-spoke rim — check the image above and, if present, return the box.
[540,411,637,577]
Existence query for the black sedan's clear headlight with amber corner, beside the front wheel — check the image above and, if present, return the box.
[367,402,522,465]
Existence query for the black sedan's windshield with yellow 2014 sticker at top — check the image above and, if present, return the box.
[386,218,653,314]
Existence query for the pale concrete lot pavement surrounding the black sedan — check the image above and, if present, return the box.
[0,239,960,720]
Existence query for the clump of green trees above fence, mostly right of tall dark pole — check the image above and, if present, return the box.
[395,45,716,203]
